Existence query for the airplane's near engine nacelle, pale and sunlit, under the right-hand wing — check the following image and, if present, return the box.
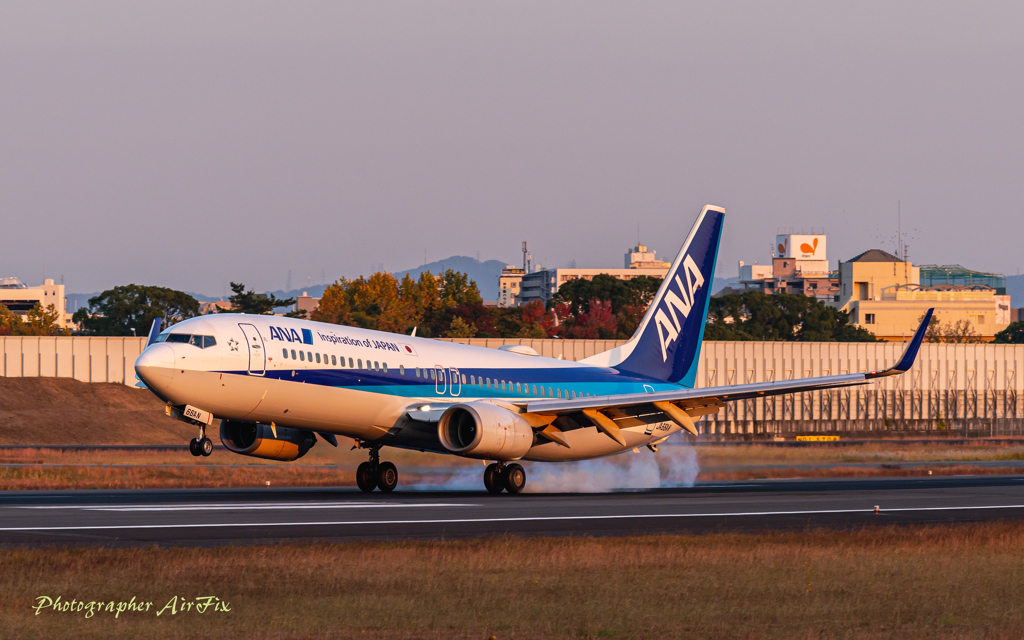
[437,402,534,460]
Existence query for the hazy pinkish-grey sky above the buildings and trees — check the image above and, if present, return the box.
[0,0,1024,294]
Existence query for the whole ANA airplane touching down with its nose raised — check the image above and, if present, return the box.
[135,206,932,494]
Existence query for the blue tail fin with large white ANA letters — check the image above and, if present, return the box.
[583,205,725,388]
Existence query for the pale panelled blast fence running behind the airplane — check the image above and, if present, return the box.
[0,337,1024,435]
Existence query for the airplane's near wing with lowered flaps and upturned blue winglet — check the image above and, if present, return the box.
[515,309,934,441]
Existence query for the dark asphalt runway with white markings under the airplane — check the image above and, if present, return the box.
[0,476,1024,546]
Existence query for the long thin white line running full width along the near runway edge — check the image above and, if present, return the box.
[0,505,1024,531]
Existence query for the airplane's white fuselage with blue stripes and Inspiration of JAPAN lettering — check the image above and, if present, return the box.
[136,313,680,461]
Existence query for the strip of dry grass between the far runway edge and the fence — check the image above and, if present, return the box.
[0,442,1024,492]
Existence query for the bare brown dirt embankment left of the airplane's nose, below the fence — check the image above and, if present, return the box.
[0,378,196,444]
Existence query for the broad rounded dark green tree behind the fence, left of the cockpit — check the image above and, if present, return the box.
[72,285,199,336]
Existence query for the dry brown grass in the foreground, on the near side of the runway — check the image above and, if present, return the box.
[6,522,1024,640]
